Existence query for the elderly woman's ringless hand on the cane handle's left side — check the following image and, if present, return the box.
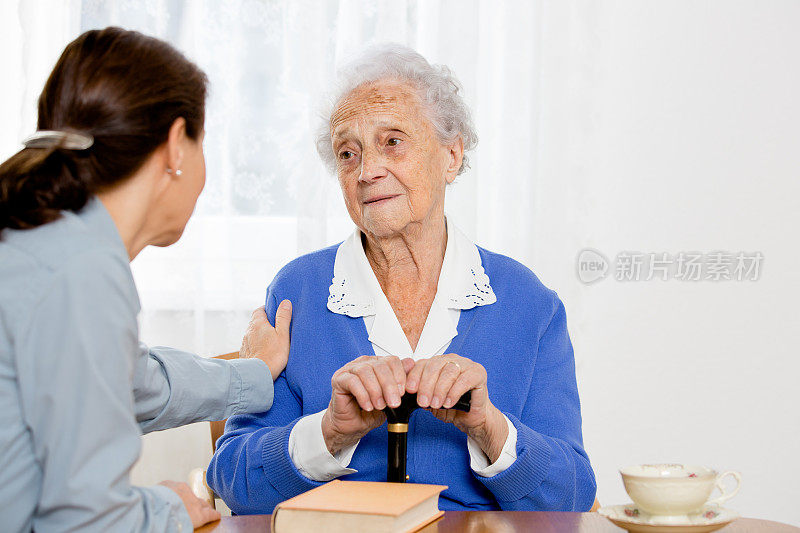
[322,355,414,455]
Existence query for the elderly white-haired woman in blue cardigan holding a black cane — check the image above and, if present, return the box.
[208,46,595,514]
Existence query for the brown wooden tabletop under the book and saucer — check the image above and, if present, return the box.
[198,511,800,533]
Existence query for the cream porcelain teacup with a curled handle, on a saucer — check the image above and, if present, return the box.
[619,464,742,516]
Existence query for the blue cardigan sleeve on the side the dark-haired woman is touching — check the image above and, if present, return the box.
[206,284,323,514]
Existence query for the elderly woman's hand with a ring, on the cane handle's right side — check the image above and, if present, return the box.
[406,354,508,463]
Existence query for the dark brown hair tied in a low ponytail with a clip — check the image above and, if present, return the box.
[0,27,208,232]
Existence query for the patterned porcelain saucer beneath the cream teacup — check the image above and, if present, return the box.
[598,503,739,533]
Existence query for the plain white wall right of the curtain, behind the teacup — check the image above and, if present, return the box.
[532,1,800,525]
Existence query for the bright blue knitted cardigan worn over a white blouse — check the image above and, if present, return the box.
[207,245,596,514]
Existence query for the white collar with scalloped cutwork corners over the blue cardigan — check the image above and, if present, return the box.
[328,218,497,317]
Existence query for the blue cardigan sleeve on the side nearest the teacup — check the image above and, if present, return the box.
[475,296,597,511]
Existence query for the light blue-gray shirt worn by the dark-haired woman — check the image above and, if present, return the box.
[0,198,272,532]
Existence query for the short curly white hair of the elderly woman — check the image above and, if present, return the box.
[317,43,478,174]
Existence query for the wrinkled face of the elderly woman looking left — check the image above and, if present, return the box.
[331,80,456,237]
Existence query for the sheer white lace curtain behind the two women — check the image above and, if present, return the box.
[0,0,552,498]
